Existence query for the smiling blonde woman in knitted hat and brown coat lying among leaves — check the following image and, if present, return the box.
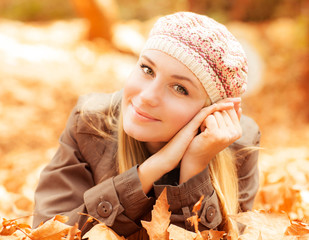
[34,12,260,237]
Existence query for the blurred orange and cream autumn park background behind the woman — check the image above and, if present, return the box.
[0,0,309,227]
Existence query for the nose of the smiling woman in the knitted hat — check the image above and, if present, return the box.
[139,79,163,107]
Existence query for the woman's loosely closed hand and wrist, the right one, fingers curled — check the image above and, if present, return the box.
[180,102,242,183]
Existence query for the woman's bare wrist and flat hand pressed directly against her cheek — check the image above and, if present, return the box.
[138,101,234,193]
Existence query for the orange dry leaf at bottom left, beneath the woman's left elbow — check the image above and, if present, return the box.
[30,215,71,240]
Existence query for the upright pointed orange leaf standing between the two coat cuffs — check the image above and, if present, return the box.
[141,188,171,240]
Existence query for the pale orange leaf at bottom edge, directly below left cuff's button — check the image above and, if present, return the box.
[83,223,125,240]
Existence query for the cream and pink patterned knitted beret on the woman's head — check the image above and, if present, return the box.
[143,12,248,103]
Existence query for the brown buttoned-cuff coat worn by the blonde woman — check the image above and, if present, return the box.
[33,92,260,236]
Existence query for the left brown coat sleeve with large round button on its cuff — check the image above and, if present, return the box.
[33,101,153,236]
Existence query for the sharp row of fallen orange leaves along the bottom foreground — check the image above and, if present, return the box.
[0,189,309,240]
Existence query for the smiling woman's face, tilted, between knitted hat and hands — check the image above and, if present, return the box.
[122,50,207,150]
